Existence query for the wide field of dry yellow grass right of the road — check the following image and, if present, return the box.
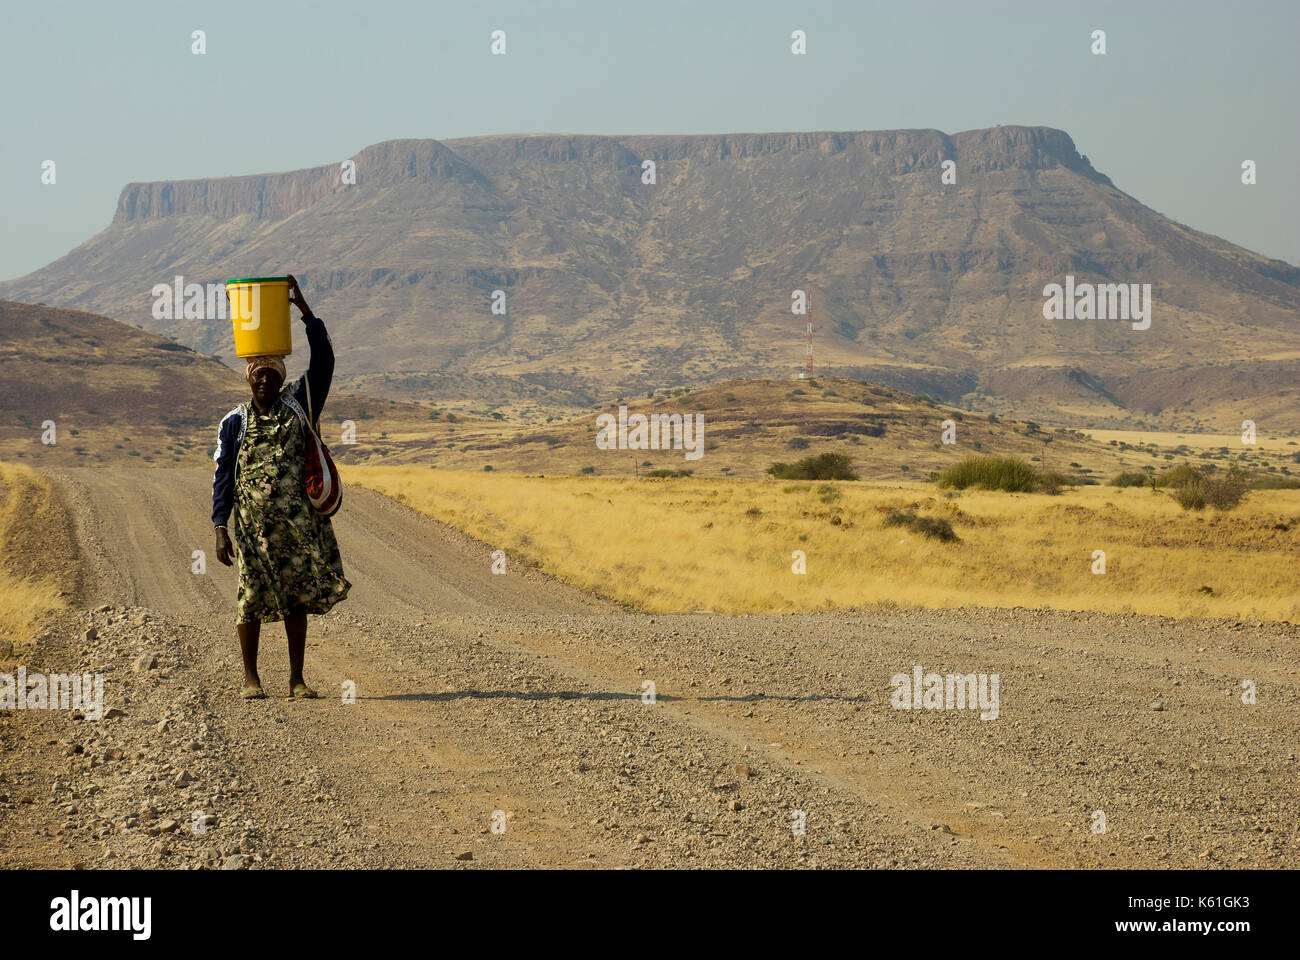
[343,466,1300,620]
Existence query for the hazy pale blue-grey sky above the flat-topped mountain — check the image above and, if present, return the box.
[0,0,1300,278]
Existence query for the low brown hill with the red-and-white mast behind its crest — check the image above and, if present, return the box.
[332,377,1167,481]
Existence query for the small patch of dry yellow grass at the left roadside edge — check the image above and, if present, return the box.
[0,463,66,647]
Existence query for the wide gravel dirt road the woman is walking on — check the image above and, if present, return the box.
[0,467,1300,869]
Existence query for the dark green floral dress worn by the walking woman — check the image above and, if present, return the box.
[234,398,352,623]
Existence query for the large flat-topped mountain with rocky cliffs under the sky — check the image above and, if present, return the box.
[0,126,1300,432]
